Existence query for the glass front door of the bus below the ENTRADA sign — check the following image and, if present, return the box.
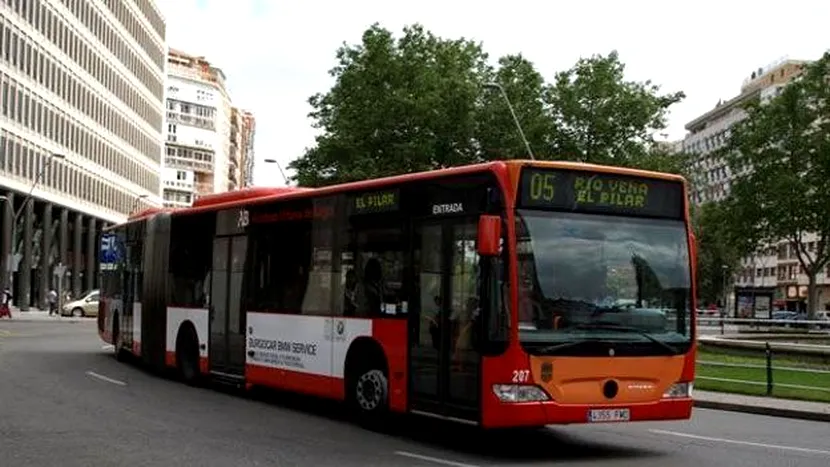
[409,219,481,422]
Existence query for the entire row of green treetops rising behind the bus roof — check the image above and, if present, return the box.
[289,24,683,186]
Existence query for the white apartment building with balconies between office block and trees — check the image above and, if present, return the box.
[163,49,254,207]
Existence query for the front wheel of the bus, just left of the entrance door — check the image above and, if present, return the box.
[349,364,389,425]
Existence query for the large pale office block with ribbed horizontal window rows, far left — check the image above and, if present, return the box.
[0,0,165,310]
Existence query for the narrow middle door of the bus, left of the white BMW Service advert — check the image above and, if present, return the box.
[209,236,247,378]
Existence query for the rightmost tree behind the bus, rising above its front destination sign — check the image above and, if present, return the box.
[546,51,685,167]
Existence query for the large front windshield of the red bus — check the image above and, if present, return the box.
[516,209,692,355]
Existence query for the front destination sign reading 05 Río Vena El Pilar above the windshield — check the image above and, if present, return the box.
[518,167,684,219]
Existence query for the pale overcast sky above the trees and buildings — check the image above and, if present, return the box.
[156,0,830,186]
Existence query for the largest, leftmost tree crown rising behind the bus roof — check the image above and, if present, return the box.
[289,25,488,186]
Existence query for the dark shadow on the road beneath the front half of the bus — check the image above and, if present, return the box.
[240,388,663,462]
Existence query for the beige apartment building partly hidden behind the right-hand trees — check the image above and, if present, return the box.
[682,59,830,316]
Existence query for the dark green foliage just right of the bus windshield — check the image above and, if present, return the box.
[692,202,742,304]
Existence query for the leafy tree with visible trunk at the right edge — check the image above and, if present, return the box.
[724,53,830,319]
